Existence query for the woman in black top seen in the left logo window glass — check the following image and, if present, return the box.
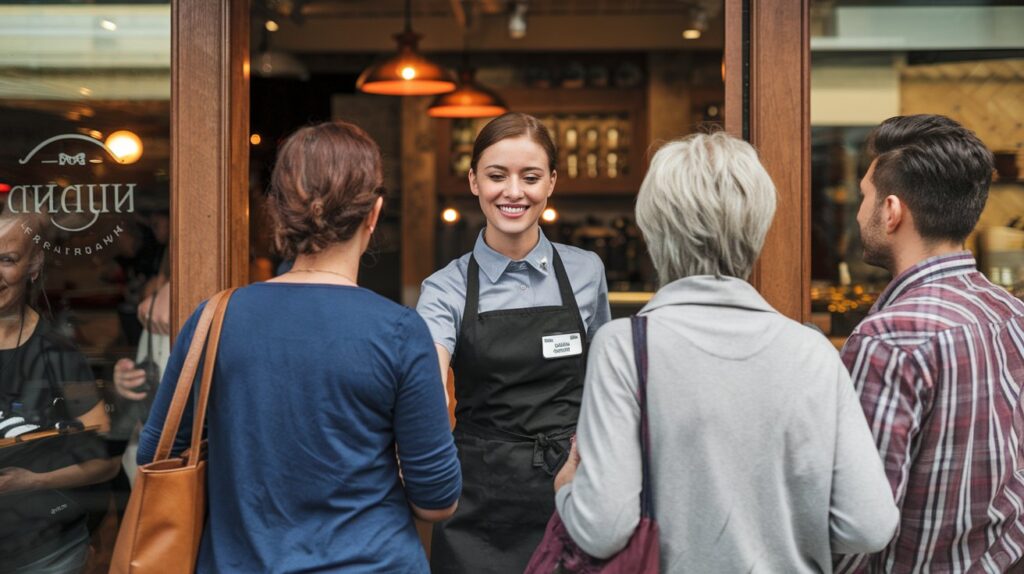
[0,205,119,574]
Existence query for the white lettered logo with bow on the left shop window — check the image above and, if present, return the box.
[5,134,136,255]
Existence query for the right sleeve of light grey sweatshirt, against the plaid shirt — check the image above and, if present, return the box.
[828,364,899,554]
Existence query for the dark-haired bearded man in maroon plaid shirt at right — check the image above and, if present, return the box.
[837,116,1024,572]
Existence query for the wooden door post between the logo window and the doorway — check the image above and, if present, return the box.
[170,0,250,334]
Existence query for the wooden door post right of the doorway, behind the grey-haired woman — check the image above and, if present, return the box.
[725,0,811,321]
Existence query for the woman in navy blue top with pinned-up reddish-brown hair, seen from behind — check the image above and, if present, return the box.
[138,122,461,572]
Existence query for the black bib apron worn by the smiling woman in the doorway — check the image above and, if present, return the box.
[430,248,587,574]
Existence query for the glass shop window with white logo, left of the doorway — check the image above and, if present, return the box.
[0,1,171,572]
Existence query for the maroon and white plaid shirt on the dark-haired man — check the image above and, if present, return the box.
[838,253,1024,572]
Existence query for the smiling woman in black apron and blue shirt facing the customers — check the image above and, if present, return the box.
[417,114,610,574]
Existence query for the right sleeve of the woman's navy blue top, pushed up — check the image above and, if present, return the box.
[394,311,462,510]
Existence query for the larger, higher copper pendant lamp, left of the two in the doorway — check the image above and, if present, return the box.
[355,0,456,95]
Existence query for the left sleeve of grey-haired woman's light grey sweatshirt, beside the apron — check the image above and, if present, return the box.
[555,319,642,558]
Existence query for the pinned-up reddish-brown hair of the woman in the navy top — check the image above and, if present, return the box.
[267,122,383,259]
